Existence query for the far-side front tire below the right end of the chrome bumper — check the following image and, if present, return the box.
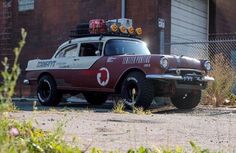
[171,90,201,109]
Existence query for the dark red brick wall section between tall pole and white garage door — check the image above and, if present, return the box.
[126,0,171,53]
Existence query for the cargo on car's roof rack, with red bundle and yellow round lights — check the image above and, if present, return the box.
[70,19,142,39]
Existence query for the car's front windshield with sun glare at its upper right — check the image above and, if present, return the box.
[105,39,150,56]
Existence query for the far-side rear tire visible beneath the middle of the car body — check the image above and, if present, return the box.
[83,92,108,105]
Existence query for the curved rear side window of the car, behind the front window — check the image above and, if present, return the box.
[56,45,78,58]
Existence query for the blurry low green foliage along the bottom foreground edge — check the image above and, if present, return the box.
[0,115,223,153]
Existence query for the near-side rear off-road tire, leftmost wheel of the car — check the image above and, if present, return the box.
[37,75,62,106]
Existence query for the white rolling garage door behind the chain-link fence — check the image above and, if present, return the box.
[171,0,208,56]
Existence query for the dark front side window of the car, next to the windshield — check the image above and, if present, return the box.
[79,42,103,56]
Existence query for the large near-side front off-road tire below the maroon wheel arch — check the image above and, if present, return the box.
[121,72,154,109]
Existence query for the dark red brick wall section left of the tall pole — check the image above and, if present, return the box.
[14,0,120,71]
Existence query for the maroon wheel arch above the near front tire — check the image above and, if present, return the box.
[115,68,146,93]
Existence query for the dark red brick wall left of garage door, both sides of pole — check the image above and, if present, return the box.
[3,0,171,95]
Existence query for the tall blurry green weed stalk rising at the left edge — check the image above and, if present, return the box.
[0,29,27,111]
